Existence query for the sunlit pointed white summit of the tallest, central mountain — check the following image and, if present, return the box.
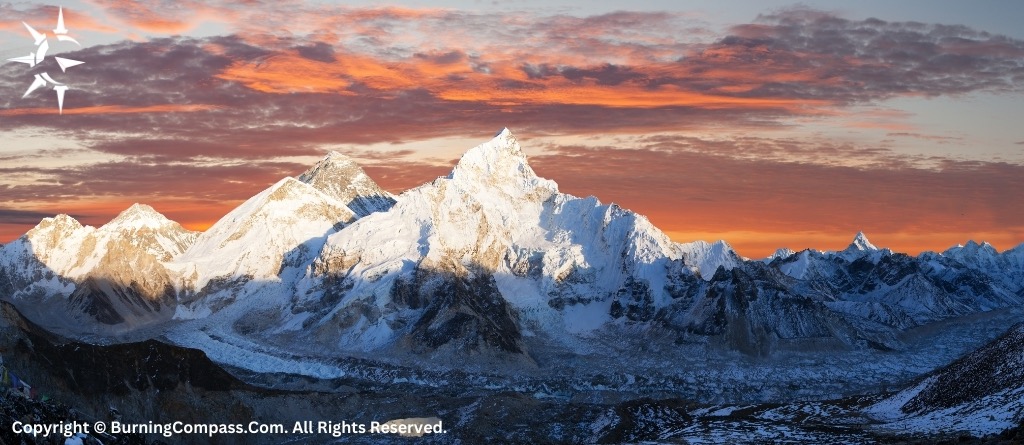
[449,128,557,194]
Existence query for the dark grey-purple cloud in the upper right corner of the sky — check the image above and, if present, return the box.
[709,9,1024,101]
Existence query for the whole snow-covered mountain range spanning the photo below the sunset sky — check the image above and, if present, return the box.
[0,129,1024,361]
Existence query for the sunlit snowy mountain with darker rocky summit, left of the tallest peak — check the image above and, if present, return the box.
[173,152,394,318]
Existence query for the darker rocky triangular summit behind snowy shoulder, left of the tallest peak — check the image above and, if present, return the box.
[298,151,394,217]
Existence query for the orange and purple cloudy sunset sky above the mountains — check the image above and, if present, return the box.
[0,0,1024,258]
